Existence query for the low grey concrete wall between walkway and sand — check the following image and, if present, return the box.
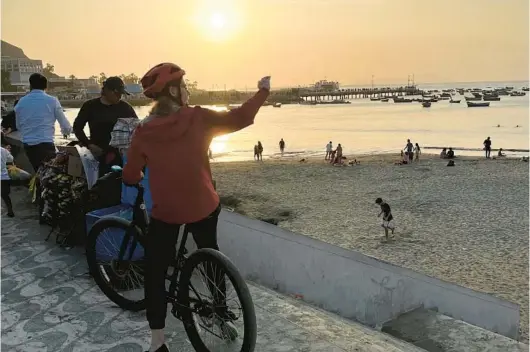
[184,211,519,339]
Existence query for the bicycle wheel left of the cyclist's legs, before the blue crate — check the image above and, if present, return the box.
[86,217,145,312]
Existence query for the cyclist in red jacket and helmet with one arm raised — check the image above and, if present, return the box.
[123,63,270,352]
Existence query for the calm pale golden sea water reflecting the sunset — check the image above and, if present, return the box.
[57,82,530,161]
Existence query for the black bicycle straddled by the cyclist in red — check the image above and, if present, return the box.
[86,166,257,352]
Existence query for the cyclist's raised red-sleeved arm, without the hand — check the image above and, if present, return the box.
[199,89,269,136]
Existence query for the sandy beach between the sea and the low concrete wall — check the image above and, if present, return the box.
[212,154,529,342]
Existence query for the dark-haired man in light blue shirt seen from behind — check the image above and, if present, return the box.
[15,73,72,172]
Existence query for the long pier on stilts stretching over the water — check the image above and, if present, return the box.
[298,86,423,101]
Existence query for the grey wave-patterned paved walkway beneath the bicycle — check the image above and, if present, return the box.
[1,190,423,352]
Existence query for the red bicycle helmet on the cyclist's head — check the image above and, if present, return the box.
[140,62,186,99]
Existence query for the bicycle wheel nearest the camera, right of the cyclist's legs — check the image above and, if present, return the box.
[178,249,257,352]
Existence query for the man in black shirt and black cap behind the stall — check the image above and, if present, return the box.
[73,77,138,176]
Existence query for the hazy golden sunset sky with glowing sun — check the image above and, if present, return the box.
[2,0,529,89]
